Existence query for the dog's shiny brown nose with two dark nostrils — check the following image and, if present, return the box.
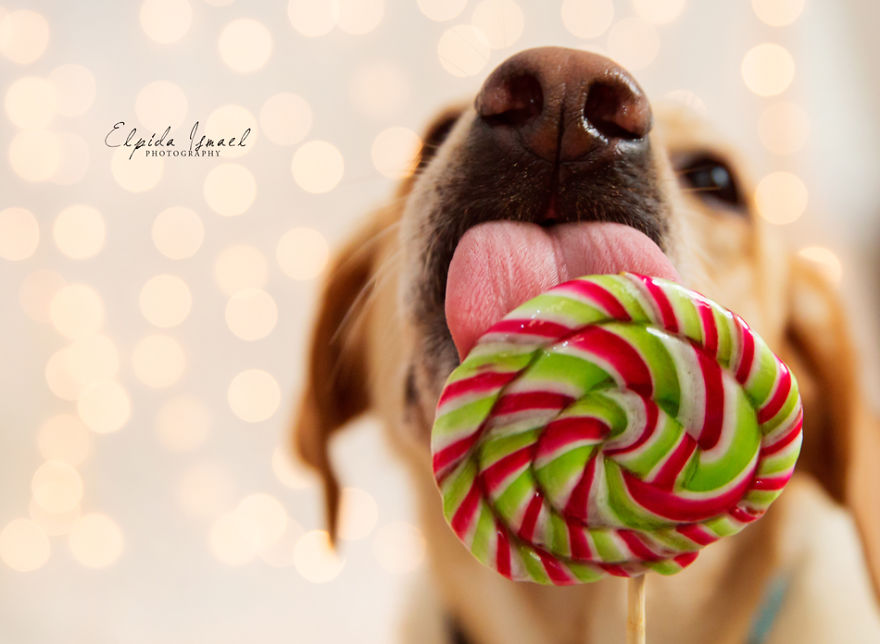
[475,47,651,161]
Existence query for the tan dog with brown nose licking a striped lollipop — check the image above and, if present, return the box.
[292,48,880,644]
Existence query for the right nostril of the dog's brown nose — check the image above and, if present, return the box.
[584,81,651,141]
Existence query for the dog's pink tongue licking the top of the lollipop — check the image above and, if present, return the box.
[446,221,679,360]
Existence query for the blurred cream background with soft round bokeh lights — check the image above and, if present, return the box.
[0,0,880,644]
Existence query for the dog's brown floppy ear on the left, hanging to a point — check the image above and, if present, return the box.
[292,218,380,540]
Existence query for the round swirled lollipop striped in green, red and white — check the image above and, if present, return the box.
[431,273,802,585]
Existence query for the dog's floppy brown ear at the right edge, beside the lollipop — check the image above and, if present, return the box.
[785,258,880,593]
